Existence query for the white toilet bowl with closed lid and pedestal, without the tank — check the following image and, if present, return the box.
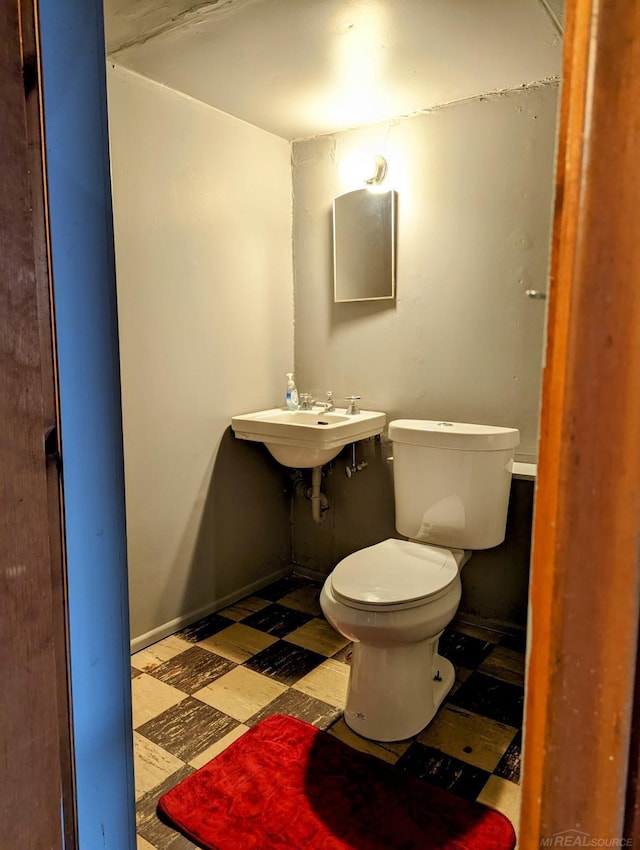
[320,539,469,741]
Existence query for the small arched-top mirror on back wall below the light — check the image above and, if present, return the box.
[333,189,396,302]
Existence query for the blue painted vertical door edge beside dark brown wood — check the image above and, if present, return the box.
[39,0,135,850]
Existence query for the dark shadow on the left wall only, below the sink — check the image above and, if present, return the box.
[178,428,291,610]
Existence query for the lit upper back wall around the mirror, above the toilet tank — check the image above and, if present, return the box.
[293,83,558,458]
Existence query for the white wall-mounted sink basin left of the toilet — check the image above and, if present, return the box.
[231,407,386,467]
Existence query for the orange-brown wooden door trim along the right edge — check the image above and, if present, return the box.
[520,0,640,850]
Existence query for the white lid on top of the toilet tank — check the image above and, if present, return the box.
[389,419,520,452]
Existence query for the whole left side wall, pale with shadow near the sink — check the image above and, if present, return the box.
[108,65,293,642]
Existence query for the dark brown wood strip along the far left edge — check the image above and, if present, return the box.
[0,0,76,848]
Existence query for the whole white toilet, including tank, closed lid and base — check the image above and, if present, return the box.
[320,419,520,741]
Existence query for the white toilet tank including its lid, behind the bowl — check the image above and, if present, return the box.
[389,419,520,549]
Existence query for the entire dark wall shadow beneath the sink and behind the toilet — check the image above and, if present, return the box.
[167,428,534,631]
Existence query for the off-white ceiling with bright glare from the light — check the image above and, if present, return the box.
[105,0,563,139]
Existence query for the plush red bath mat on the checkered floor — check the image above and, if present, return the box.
[158,714,516,850]
